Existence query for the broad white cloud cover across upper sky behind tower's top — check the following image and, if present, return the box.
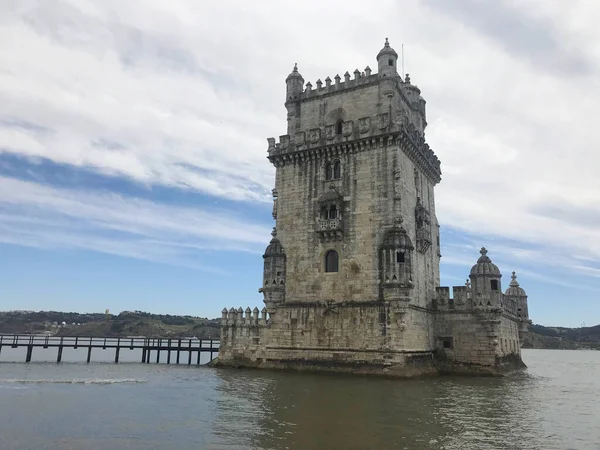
[0,0,600,286]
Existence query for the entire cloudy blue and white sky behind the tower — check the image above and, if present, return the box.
[0,0,600,326]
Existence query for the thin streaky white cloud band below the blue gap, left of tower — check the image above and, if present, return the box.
[0,177,269,272]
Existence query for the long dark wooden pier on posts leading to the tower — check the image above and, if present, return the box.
[0,335,220,365]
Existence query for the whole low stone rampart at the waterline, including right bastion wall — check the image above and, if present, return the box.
[214,302,524,377]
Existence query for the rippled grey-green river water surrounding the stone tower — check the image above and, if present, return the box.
[0,350,600,450]
